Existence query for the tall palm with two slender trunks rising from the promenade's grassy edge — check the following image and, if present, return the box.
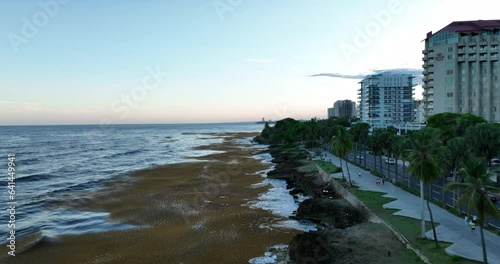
[407,128,442,247]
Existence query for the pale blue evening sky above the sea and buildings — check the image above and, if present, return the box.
[0,0,500,125]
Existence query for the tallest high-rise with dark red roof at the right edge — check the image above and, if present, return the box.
[423,20,500,122]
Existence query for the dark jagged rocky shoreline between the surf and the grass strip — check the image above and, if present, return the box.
[256,143,414,263]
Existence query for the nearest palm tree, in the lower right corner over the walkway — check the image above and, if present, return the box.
[446,155,500,263]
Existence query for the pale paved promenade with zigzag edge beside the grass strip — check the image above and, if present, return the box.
[323,152,500,263]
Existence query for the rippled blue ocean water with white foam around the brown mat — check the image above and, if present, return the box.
[0,123,315,261]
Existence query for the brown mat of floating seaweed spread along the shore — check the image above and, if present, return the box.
[8,133,301,263]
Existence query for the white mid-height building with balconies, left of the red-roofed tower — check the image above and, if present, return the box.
[358,72,415,125]
